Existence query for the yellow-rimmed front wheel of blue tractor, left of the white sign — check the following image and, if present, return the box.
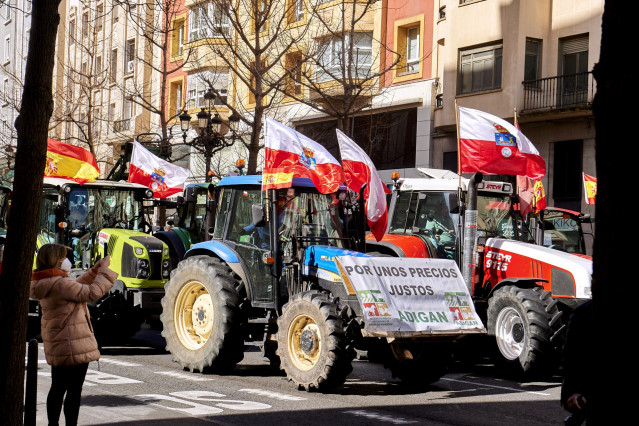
[277,291,355,391]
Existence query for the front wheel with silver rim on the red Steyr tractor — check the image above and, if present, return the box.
[488,286,561,374]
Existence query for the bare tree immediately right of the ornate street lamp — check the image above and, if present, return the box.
[182,0,306,174]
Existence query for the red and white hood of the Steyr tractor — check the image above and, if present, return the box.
[484,238,592,299]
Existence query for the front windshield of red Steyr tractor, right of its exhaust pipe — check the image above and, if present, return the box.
[477,193,515,239]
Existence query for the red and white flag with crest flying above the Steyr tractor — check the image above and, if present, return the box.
[458,107,546,179]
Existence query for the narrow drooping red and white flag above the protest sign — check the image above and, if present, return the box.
[336,129,391,241]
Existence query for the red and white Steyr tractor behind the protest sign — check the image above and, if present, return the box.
[367,173,592,374]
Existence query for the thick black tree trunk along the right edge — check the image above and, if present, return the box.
[584,0,636,424]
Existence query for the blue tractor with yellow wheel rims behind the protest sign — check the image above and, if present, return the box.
[161,175,484,391]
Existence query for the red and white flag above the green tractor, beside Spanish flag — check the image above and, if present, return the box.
[129,142,189,198]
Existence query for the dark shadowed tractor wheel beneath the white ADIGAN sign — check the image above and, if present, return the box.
[384,341,452,391]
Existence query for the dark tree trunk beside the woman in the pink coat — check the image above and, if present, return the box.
[0,0,60,425]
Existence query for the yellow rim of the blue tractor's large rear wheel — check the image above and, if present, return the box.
[173,281,215,350]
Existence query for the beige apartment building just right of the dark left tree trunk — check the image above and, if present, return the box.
[51,0,161,177]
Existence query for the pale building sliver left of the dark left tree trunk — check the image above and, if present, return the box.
[0,0,32,173]
